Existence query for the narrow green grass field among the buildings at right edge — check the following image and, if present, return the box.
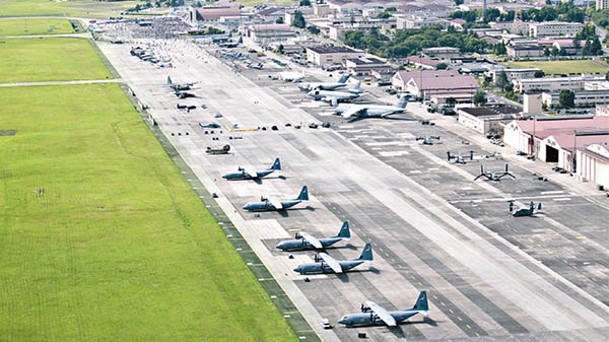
[501,60,609,75]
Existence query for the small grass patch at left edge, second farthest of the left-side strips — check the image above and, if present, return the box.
[0,18,74,36]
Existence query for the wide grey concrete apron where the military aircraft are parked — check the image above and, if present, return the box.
[99,41,609,341]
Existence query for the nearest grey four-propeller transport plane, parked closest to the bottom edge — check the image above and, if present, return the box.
[338,291,429,328]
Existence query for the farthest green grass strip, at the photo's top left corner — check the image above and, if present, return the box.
[0,0,143,18]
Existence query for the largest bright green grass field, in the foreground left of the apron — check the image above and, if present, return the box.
[0,84,296,341]
